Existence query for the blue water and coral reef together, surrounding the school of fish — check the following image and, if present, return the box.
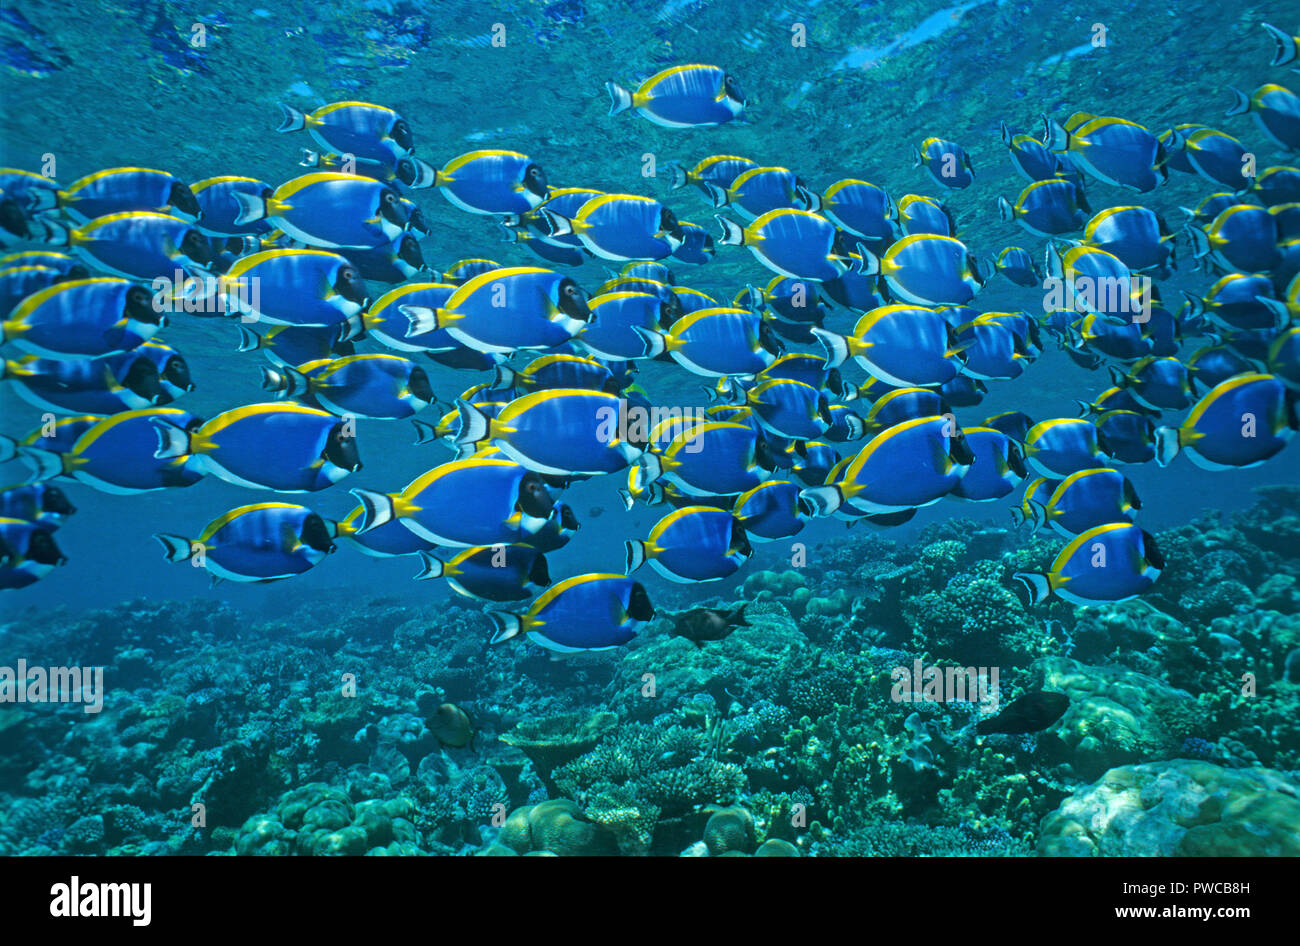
[0,0,1300,856]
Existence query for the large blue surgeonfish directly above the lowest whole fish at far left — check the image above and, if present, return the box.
[152,402,361,492]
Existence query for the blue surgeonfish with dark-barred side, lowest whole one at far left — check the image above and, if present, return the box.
[153,503,335,582]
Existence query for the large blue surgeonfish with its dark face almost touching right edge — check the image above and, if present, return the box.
[1156,373,1300,470]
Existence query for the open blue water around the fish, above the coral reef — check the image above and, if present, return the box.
[0,0,1300,852]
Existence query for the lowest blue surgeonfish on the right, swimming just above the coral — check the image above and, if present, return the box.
[1014,522,1165,606]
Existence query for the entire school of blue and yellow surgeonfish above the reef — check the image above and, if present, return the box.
[0,42,1300,652]
